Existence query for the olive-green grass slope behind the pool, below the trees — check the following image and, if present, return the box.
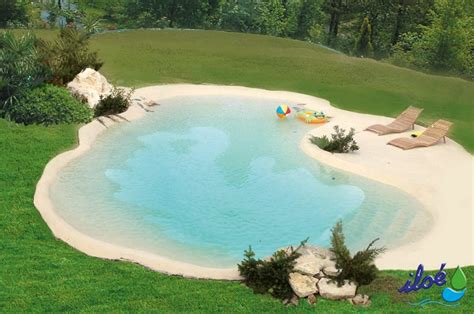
[88,30,474,152]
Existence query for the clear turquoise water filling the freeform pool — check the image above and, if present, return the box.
[50,96,430,267]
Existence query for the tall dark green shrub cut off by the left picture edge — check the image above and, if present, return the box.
[0,32,48,117]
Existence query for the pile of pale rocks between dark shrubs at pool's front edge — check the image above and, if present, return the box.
[284,245,370,306]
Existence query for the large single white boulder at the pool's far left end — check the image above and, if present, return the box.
[67,68,114,108]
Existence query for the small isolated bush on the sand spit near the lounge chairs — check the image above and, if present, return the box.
[310,125,359,153]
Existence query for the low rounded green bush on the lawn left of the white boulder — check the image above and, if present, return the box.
[5,85,92,125]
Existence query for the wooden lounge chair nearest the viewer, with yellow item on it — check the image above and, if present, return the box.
[387,120,453,149]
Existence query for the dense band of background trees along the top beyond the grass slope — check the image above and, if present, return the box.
[24,0,474,79]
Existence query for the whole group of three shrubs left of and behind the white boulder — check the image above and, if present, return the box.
[0,28,102,125]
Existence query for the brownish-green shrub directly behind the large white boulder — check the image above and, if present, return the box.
[39,28,103,85]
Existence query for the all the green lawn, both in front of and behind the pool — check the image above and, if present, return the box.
[0,31,474,313]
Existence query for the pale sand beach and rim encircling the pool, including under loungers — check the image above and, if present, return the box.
[34,84,474,280]
